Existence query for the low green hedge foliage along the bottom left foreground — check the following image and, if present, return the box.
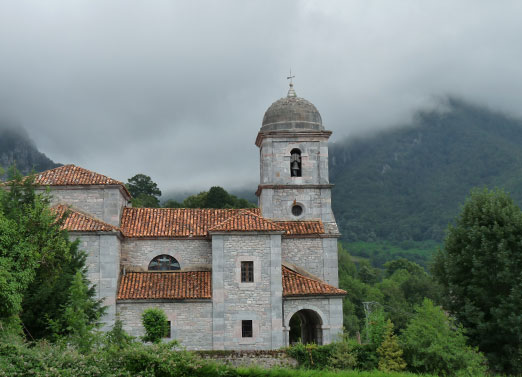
[0,334,436,377]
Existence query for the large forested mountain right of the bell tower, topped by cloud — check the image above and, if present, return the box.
[330,99,522,242]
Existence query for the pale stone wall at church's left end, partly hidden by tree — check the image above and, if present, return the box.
[70,232,120,330]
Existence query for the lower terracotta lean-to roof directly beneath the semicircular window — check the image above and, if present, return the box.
[118,271,212,300]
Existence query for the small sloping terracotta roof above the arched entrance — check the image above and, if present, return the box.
[282,266,346,297]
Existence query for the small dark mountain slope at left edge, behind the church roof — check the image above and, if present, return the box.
[0,124,61,179]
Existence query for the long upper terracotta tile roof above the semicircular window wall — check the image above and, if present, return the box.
[121,208,259,237]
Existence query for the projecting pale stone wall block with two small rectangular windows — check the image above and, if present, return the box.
[212,233,283,350]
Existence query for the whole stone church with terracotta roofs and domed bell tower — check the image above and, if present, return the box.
[32,84,346,350]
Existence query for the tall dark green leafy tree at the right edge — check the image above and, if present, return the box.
[433,189,522,374]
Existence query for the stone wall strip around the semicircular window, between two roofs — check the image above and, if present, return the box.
[121,238,212,271]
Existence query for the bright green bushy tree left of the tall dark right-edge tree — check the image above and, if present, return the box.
[400,299,485,376]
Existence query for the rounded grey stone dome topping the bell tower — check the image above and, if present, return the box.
[261,83,324,132]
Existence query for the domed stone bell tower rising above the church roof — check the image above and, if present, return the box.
[256,82,337,228]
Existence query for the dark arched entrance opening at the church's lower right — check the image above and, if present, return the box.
[289,309,323,345]
